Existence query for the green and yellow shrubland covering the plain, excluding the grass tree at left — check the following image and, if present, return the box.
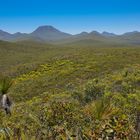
[0,42,140,140]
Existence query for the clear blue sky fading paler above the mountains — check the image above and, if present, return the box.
[0,0,140,34]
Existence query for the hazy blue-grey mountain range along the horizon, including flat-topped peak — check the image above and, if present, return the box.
[0,25,140,44]
